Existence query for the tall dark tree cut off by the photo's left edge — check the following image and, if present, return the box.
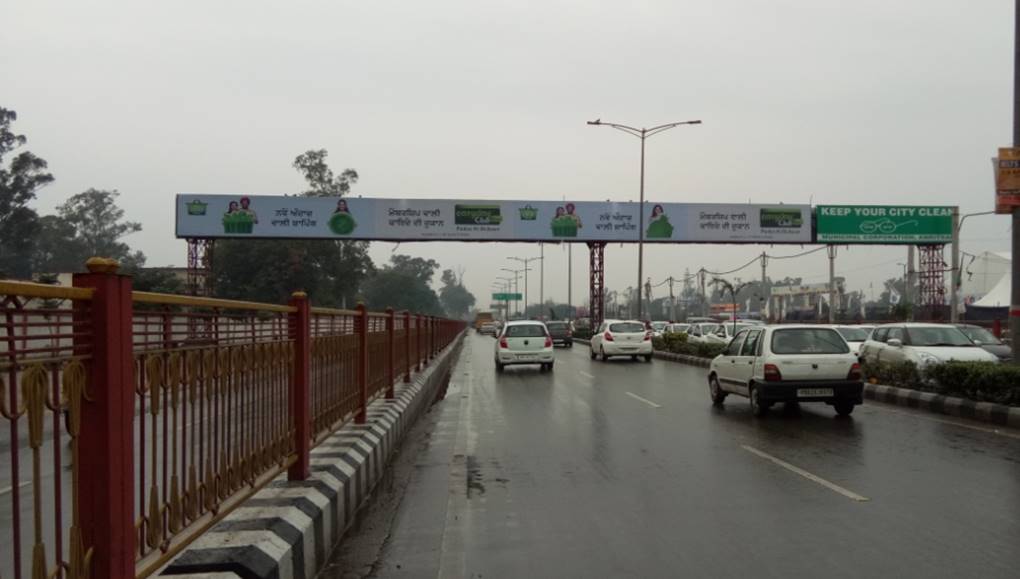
[0,107,53,277]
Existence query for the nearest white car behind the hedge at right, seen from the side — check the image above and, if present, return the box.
[861,323,999,367]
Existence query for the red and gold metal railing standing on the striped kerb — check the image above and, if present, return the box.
[0,259,465,579]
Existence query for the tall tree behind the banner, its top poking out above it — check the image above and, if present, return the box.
[212,149,374,307]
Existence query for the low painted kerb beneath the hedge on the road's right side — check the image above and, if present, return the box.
[574,339,1020,428]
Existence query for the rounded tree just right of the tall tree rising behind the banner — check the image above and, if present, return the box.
[363,255,443,316]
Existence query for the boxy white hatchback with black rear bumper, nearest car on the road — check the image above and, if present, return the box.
[708,325,864,416]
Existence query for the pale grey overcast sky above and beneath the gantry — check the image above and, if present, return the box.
[0,0,1013,311]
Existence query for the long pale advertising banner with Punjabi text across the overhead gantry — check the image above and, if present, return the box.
[176,195,811,244]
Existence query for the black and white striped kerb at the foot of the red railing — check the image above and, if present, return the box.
[161,337,462,579]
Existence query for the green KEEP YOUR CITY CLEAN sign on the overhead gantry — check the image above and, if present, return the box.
[815,205,955,244]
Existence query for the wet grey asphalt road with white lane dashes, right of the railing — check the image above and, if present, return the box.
[320,334,1020,579]
